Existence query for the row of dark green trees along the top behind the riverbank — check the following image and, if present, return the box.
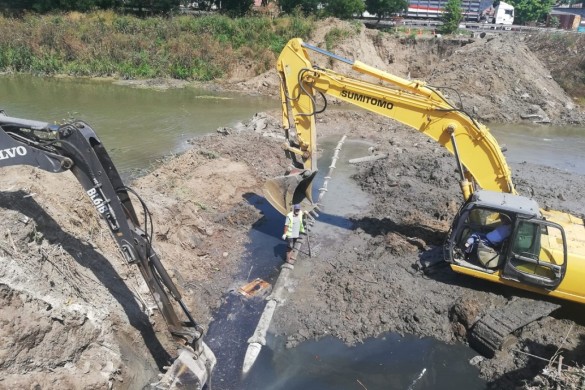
[0,0,556,25]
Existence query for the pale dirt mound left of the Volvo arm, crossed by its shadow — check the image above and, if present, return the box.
[0,168,145,389]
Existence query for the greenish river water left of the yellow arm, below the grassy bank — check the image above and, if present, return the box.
[0,76,278,177]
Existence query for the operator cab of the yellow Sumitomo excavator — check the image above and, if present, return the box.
[445,190,567,291]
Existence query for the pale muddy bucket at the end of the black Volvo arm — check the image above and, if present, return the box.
[154,342,217,390]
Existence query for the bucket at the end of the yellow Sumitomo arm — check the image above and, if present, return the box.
[264,169,317,215]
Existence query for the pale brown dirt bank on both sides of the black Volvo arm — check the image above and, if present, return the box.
[0,115,283,389]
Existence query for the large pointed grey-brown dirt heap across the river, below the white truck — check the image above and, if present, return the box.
[416,34,582,123]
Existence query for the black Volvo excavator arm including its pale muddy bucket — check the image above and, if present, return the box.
[0,112,215,388]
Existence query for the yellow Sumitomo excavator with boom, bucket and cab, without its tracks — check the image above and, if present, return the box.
[265,38,585,312]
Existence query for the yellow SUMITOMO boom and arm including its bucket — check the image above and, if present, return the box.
[266,38,515,213]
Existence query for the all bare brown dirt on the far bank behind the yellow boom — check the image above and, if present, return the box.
[229,19,585,124]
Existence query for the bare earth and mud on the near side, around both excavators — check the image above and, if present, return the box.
[0,110,585,388]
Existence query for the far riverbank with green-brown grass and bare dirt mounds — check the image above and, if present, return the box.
[0,11,585,109]
